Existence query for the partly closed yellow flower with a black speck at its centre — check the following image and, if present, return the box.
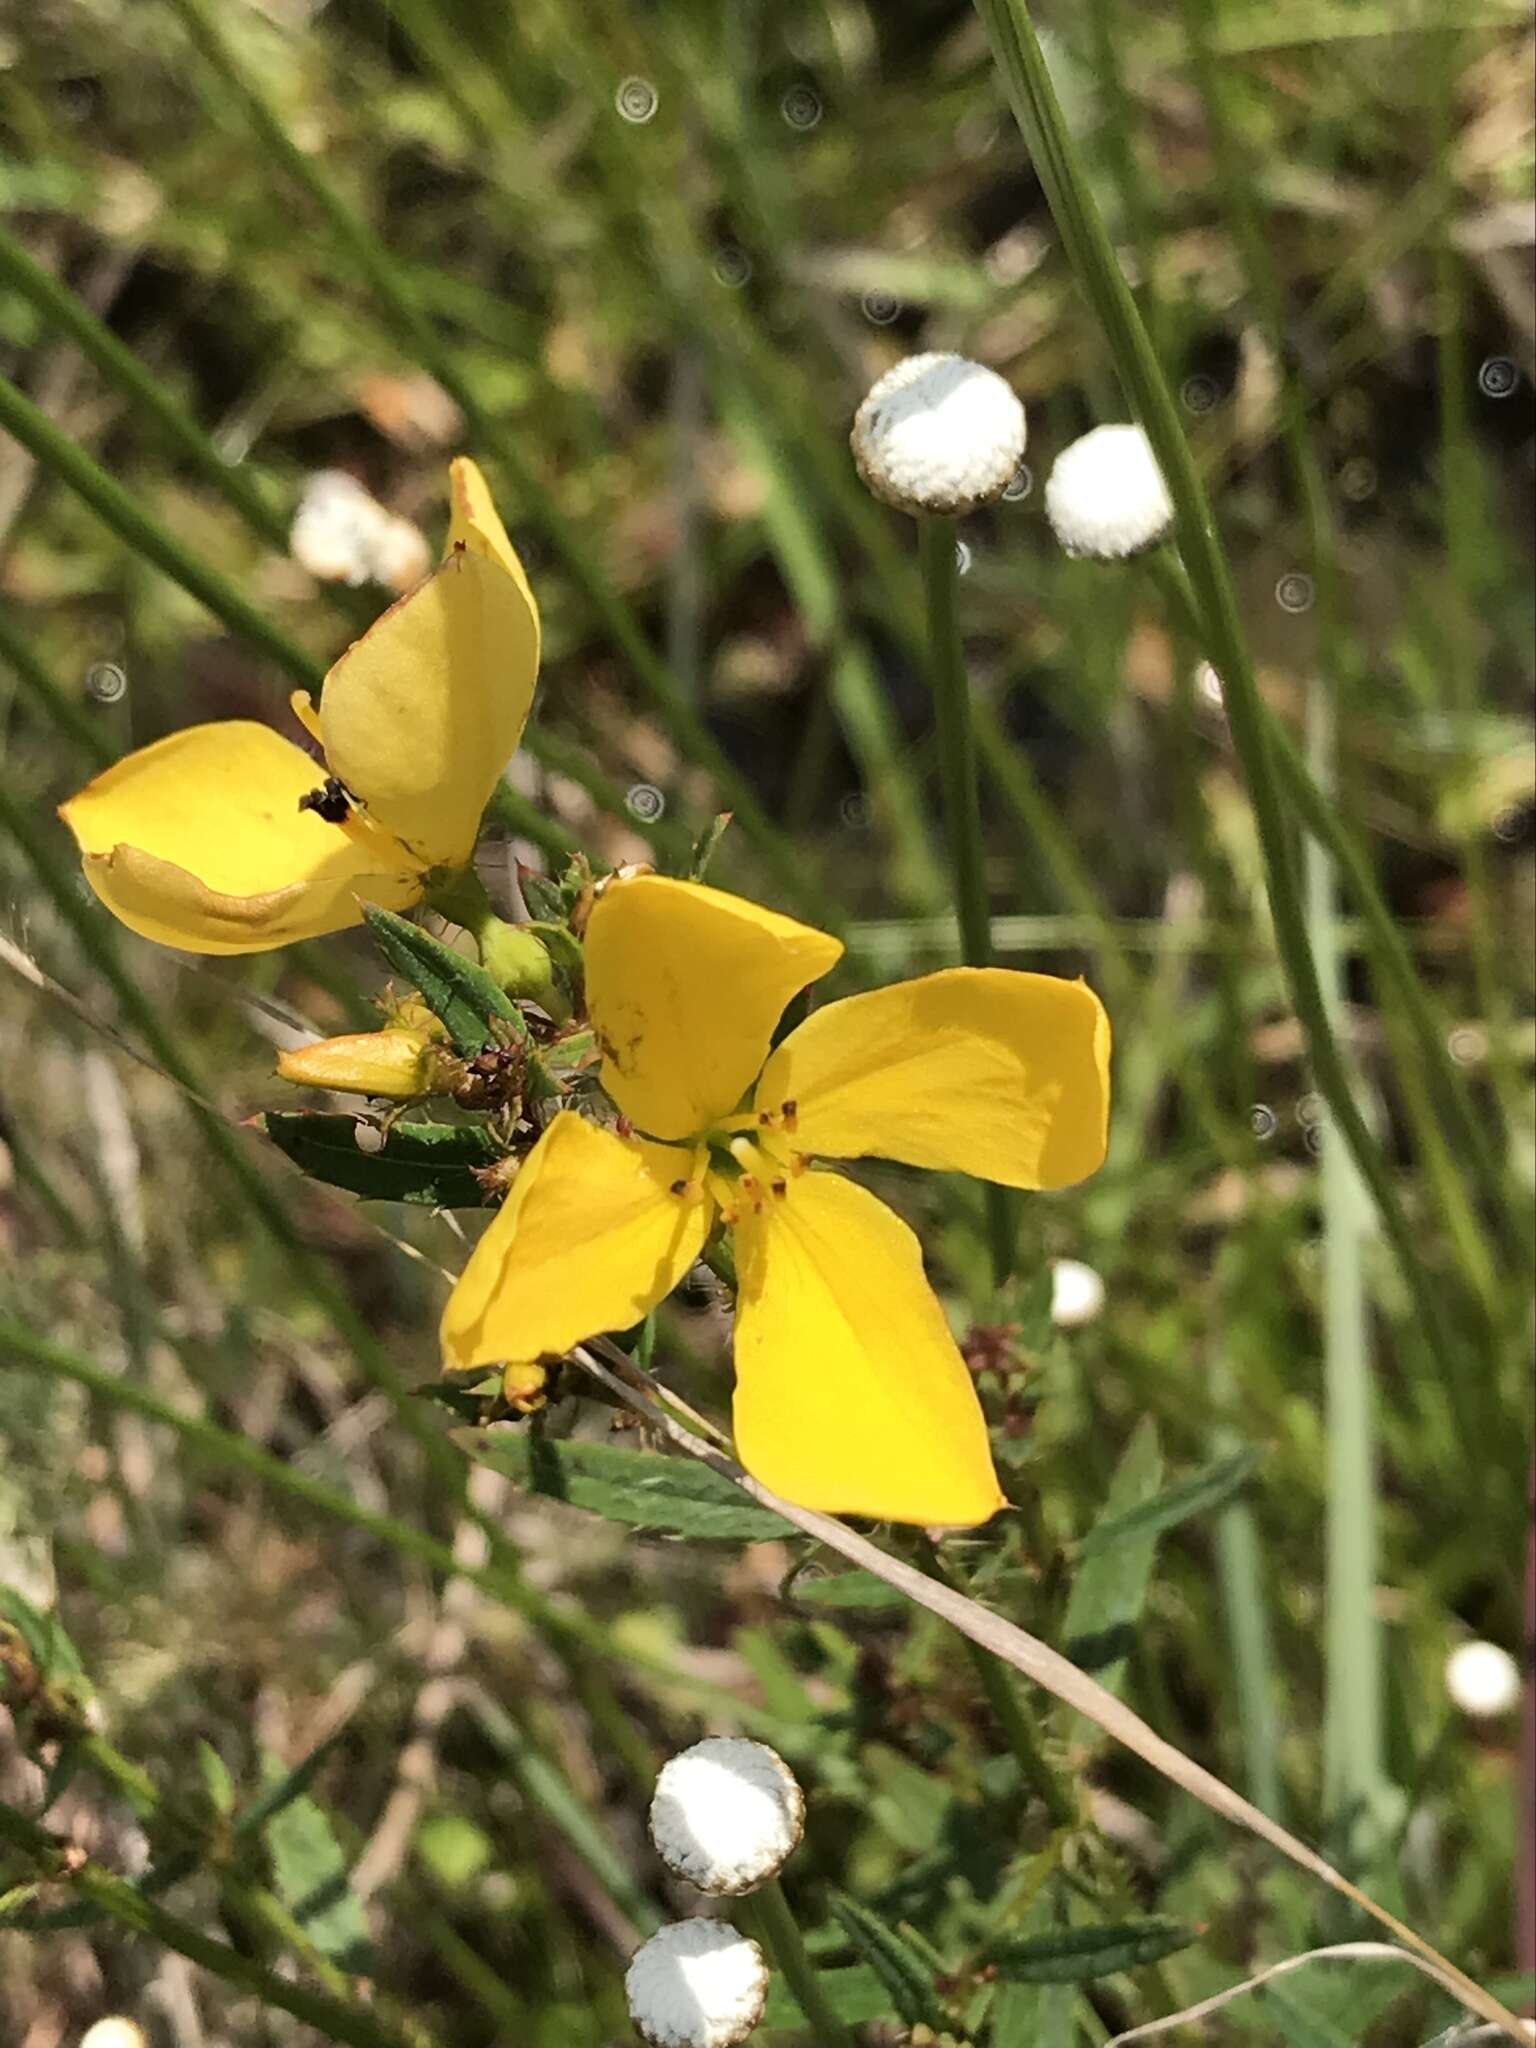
[59,457,539,952]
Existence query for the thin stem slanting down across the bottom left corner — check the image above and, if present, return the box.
[0,1804,430,2048]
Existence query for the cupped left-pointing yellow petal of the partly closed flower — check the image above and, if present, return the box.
[59,719,422,952]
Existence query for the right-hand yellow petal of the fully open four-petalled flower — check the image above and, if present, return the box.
[756,967,1110,1188]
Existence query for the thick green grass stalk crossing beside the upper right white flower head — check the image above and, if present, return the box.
[977,0,1462,1376]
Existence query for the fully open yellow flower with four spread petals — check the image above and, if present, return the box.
[442,874,1110,1524]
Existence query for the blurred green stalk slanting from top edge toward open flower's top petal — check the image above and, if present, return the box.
[166,0,825,920]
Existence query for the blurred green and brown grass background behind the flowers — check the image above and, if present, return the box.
[0,0,1536,2048]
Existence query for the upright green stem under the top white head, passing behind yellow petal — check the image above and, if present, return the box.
[918,518,1016,1286]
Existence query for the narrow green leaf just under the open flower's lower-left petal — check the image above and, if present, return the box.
[459,1432,795,1542]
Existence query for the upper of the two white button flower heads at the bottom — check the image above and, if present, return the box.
[651,1735,805,1896]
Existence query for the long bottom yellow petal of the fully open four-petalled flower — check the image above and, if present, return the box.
[735,1174,1006,1526]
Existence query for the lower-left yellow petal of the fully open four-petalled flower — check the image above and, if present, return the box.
[442,1110,709,1368]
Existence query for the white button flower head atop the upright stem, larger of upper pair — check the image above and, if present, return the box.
[850,354,1024,514]
